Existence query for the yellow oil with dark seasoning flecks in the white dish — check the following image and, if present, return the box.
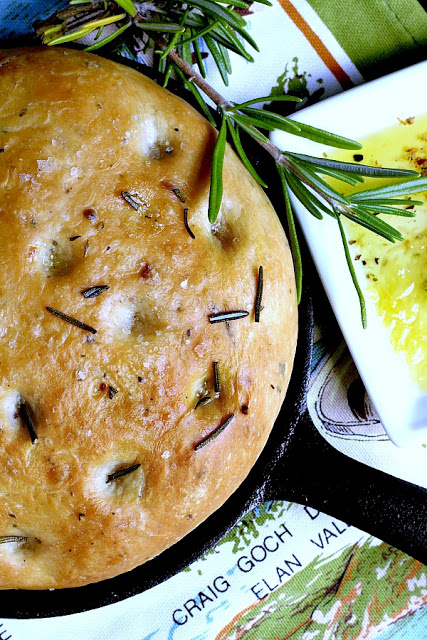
[332,116,427,389]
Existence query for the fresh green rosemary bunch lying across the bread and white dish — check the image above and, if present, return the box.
[36,0,427,326]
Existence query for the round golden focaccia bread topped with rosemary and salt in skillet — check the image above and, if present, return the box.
[0,48,297,589]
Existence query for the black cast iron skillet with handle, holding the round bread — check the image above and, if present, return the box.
[0,43,427,618]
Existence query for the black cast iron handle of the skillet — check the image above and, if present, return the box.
[263,409,427,564]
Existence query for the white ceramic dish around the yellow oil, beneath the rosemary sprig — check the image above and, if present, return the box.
[272,61,427,446]
